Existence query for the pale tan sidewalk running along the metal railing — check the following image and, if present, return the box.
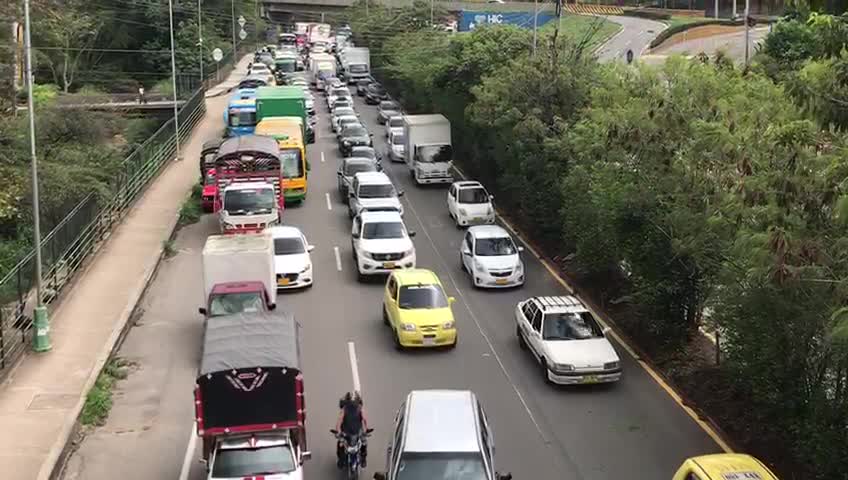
[0,59,246,480]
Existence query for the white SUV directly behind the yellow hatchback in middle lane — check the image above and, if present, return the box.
[350,212,415,280]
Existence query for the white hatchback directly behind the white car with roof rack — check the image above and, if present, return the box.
[459,225,524,288]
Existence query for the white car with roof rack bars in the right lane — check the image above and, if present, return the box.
[515,295,621,385]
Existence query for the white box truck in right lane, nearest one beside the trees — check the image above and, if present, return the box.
[403,114,453,185]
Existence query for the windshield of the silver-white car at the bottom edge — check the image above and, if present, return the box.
[394,452,488,480]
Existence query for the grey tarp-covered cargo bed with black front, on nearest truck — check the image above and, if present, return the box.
[195,312,303,435]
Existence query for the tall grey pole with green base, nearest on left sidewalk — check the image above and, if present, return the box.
[24,0,51,352]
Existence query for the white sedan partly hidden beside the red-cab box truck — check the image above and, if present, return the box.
[269,226,315,290]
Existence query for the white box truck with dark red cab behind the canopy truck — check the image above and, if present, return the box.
[200,231,277,317]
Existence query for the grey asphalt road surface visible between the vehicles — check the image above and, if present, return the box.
[63,84,719,480]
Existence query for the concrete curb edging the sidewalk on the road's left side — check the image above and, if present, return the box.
[37,209,184,480]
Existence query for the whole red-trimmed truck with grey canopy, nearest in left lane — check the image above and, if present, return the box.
[194,312,312,479]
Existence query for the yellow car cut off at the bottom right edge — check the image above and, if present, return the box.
[672,453,778,480]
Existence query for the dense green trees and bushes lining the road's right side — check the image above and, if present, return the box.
[350,2,848,479]
